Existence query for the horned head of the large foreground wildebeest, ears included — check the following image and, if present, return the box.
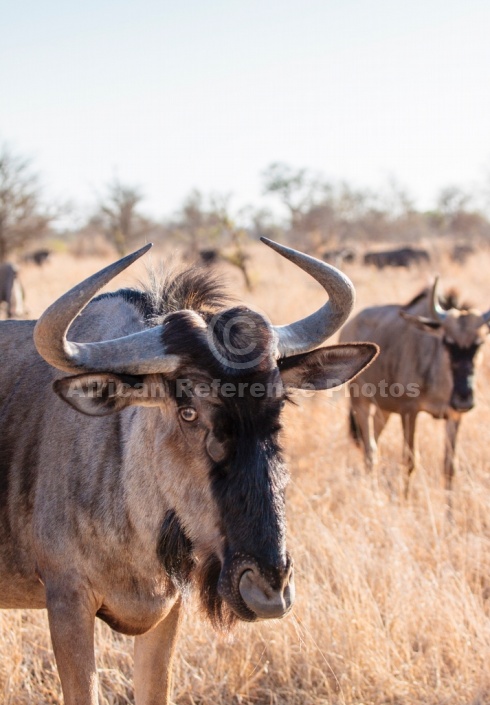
[34,241,377,623]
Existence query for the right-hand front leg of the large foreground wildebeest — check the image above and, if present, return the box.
[134,598,181,705]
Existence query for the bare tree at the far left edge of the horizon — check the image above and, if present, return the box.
[0,145,54,262]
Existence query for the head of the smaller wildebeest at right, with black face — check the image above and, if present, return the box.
[400,278,490,413]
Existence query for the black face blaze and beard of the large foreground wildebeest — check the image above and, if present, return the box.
[140,288,289,628]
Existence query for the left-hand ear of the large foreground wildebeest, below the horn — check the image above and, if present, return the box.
[53,372,161,416]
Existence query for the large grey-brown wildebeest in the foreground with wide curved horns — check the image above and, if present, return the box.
[0,241,376,705]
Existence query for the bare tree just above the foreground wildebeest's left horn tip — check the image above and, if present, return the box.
[98,179,149,256]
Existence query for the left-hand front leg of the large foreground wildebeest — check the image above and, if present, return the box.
[47,586,99,705]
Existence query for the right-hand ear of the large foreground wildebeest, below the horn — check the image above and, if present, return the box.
[278,343,379,389]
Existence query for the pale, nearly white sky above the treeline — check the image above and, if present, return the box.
[0,0,490,217]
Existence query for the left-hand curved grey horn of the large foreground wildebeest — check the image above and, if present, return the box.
[33,244,177,374]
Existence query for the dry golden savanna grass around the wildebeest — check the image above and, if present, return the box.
[0,239,490,705]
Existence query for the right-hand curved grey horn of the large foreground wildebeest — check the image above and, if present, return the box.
[260,237,356,357]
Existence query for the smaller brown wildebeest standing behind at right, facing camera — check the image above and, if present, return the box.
[340,280,490,491]
